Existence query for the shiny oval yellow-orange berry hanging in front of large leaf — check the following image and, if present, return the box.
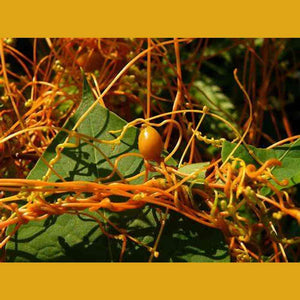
[138,126,163,161]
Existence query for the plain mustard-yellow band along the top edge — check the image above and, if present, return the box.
[0,0,300,37]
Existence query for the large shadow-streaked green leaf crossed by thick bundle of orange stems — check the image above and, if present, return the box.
[6,78,229,262]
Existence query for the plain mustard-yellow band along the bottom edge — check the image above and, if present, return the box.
[0,263,299,300]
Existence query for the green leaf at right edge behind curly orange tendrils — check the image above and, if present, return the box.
[222,139,300,193]
